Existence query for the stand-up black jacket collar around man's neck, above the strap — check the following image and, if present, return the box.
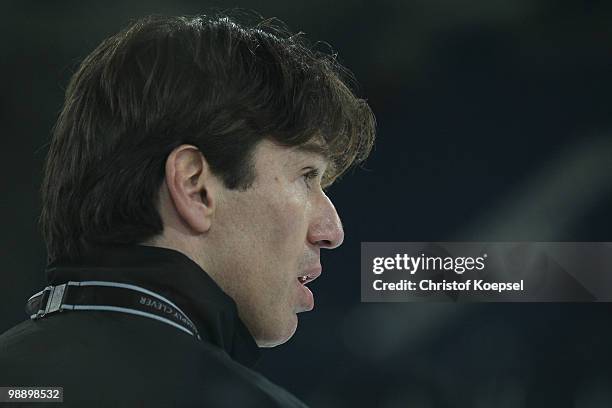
[46,244,260,367]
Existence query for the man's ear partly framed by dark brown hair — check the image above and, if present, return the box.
[166,145,216,234]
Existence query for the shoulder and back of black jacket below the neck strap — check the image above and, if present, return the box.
[0,312,304,407]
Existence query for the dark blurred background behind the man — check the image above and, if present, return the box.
[0,0,612,408]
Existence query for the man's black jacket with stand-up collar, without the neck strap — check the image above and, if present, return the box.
[0,245,304,407]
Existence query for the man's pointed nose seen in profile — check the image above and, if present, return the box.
[308,193,344,249]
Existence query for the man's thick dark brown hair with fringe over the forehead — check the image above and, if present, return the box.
[41,15,375,262]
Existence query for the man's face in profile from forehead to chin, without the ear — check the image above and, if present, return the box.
[209,140,344,347]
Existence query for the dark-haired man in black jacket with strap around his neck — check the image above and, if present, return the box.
[0,16,374,407]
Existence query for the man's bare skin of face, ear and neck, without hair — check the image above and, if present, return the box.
[149,140,344,346]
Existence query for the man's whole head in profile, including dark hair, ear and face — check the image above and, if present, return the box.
[41,17,374,346]
